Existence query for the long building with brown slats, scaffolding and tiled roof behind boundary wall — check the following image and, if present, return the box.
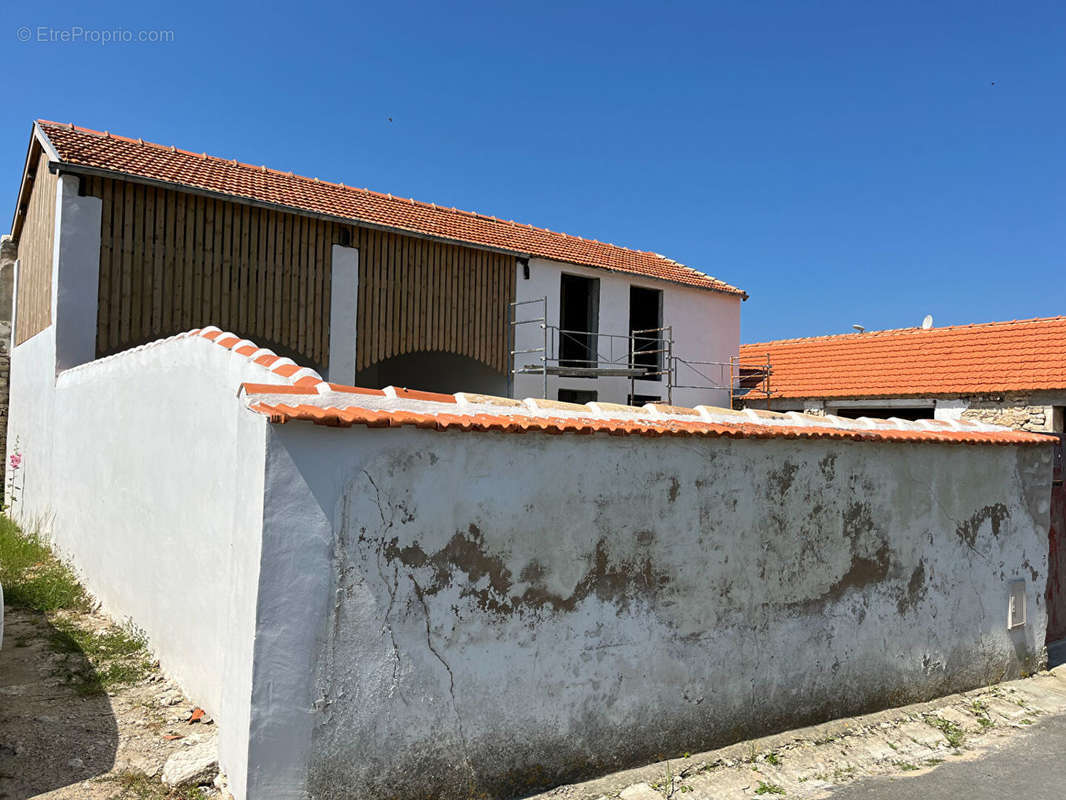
[12,122,746,404]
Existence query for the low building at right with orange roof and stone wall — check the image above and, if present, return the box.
[741,317,1066,433]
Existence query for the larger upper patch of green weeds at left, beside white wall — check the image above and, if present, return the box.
[0,516,88,612]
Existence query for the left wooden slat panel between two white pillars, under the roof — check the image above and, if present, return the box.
[90,177,334,369]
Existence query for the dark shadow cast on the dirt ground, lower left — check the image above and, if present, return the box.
[0,607,118,800]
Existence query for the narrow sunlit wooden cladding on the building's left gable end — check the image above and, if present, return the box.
[15,154,56,345]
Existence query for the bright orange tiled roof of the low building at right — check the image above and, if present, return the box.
[740,317,1066,398]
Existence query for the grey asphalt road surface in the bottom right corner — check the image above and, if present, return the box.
[833,716,1066,800]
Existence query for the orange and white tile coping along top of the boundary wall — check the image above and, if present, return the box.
[70,326,1056,446]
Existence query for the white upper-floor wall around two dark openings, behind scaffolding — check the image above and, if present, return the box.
[514,258,741,406]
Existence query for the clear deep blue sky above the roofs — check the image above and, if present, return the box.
[0,0,1066,341]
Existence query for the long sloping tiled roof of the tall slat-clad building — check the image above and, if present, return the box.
[37,121,747,299]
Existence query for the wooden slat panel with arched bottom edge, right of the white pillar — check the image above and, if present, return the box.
[353,228,515,372]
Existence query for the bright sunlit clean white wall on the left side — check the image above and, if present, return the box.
[11,327,309,799]
